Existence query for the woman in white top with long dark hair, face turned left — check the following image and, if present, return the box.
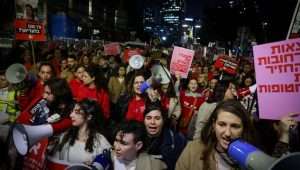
[49,99,111,164]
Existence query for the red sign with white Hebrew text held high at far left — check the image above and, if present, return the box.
[15,19,46,41]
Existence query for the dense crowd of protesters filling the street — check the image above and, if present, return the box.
[0,39,300,170]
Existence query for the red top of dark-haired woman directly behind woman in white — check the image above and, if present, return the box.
[77,86,110,120]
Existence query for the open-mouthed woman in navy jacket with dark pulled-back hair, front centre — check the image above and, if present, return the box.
[144,104,186,170]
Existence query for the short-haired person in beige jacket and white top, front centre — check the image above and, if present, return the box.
[93,121,166,170]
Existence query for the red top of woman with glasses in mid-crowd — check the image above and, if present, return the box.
[126,97,146,122]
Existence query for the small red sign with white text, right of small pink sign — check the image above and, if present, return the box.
[214,56,238,75]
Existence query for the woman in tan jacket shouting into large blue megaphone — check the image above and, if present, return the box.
[176,100,255,170]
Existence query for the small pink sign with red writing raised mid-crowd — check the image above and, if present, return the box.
[170,46,195,78]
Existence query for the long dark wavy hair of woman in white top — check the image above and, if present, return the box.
[59,99,104,152]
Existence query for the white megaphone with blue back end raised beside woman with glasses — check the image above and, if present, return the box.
[140,64,171,93]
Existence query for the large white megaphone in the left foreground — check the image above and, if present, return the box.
[12,124,53,155]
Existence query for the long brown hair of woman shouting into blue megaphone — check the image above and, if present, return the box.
[201,99,255,169]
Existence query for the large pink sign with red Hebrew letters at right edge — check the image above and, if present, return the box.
[253,39,300,120]
